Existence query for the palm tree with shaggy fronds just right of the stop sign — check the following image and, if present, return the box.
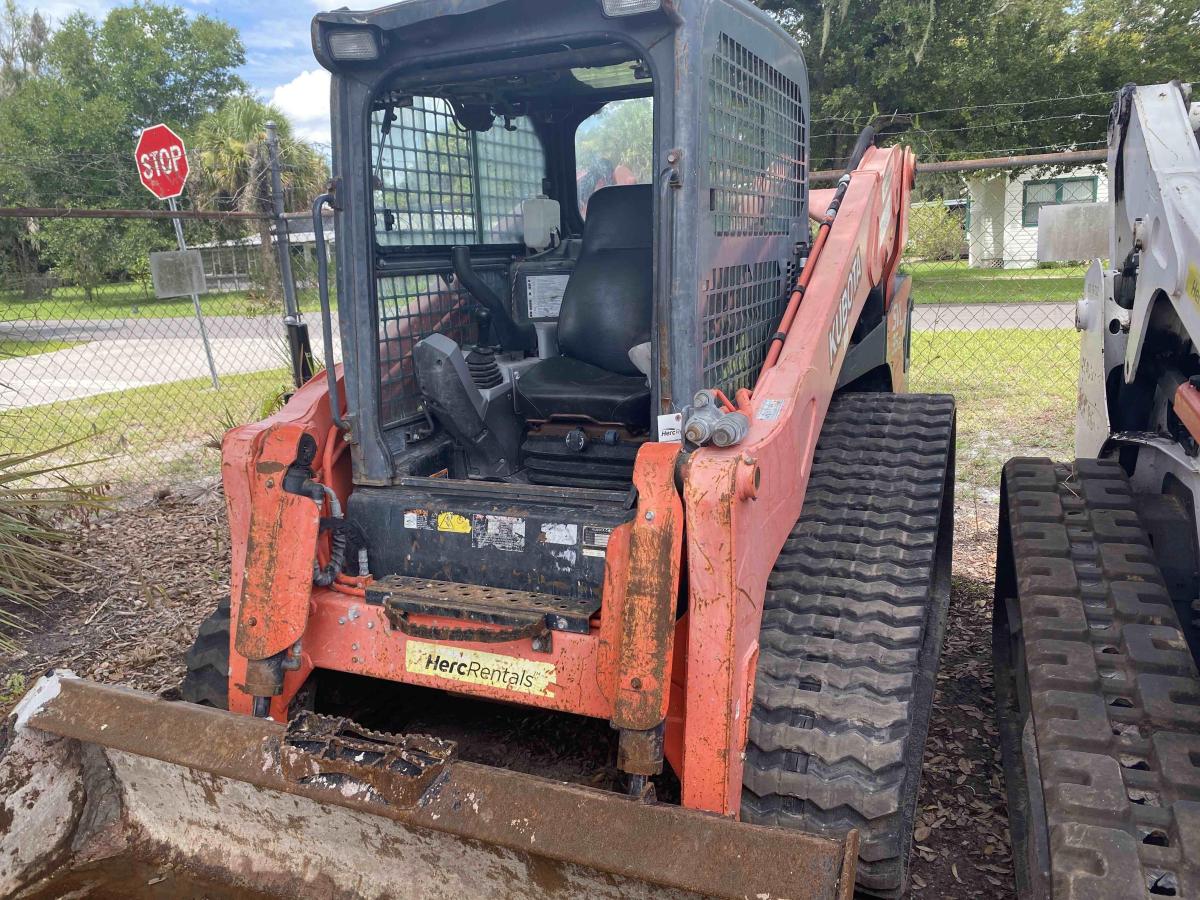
[192,95,329,301]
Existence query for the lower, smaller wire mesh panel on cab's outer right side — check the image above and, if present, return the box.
[701,262,785,397]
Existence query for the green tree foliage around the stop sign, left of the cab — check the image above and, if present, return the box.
[0,0,325,300]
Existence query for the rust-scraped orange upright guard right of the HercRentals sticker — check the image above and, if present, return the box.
[612,443,683,731]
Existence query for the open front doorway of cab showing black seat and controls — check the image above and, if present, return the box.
[371,41,654,488]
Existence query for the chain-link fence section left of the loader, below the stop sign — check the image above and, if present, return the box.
[0,207,328,481]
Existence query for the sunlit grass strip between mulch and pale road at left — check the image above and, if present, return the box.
[0,368,288,480]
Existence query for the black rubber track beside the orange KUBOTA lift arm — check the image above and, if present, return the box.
[742,394,954,896]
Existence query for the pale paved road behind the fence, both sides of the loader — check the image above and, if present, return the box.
[0,304,1075,408]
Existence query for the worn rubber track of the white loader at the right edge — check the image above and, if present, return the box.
[994,460,1200,900]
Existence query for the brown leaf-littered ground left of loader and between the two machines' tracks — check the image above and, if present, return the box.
[0,489,1013,900]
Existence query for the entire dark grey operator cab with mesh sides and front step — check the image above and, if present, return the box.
[313,0,810,634]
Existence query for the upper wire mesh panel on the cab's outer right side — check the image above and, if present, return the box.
[708,34,805,235]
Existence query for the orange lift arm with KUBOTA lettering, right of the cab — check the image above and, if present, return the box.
[683,142,910,815]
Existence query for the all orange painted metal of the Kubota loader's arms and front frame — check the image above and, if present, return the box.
[226,148,912,816]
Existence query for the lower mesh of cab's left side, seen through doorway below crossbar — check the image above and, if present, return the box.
[377,266,508,427]
